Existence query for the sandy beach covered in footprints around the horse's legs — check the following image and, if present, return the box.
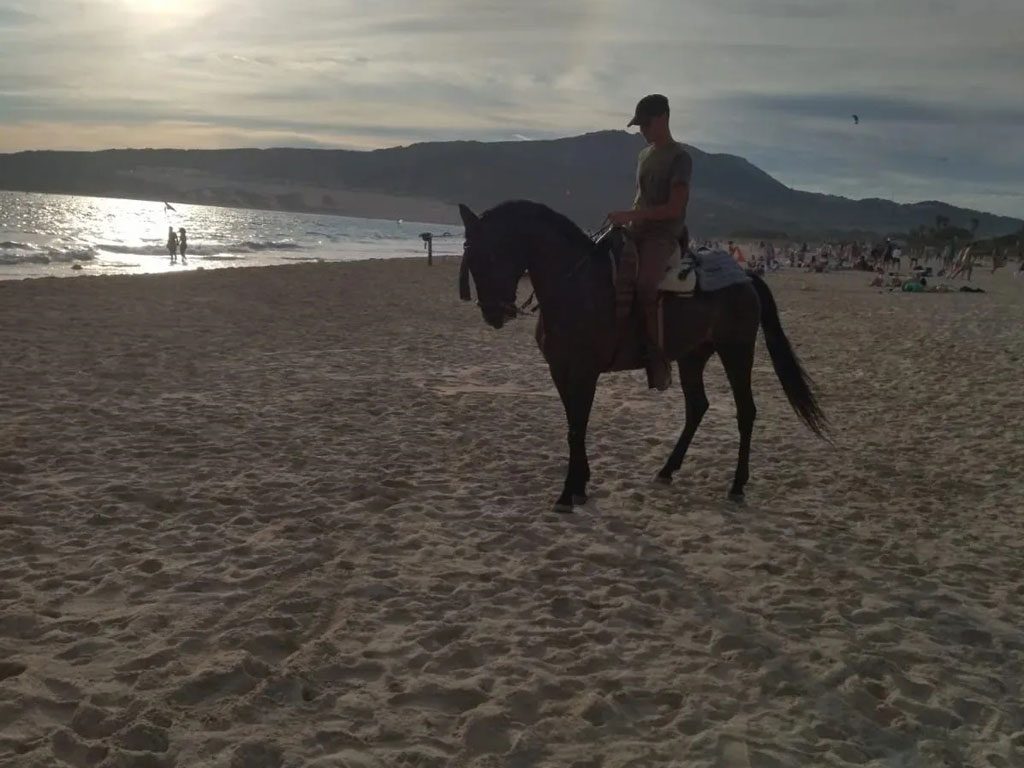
[0,260,1024,768]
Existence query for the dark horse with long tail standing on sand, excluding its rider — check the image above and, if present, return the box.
[459,201,827,511]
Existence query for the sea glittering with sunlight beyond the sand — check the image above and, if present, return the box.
[0,191,463,280]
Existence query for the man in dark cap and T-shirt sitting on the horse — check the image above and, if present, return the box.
[608,93,693,391]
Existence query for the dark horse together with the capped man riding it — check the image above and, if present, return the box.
[459,95,827,512]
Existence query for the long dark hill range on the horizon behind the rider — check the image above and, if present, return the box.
[0,131,1024,237]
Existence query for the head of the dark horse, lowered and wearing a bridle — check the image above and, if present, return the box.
[459,204,526,328]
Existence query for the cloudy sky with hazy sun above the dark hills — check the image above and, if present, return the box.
[0,0,1024,217]
